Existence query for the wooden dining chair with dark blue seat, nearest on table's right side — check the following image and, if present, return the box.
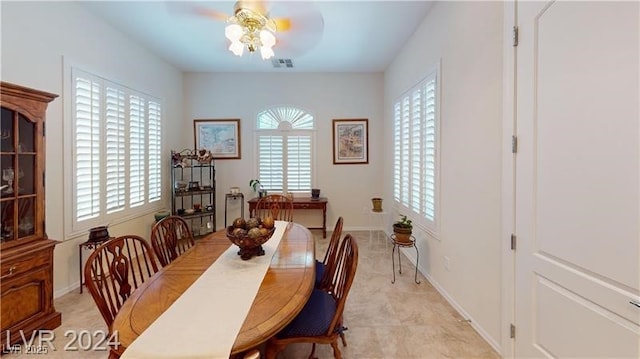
[266,234,358,359]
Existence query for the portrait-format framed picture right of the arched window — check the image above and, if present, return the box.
[333,119,369,165]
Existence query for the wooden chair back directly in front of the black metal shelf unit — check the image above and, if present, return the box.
[151,216,195,267]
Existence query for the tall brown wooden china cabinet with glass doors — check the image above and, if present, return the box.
[0,82,61,346]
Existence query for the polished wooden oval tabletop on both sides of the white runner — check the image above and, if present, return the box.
[109,223,315,358]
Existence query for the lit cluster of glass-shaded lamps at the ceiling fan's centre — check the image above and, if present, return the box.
[224,2,276,60]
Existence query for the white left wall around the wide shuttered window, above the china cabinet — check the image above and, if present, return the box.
[1,1,183,296]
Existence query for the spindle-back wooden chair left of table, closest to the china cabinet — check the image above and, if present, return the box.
[84,235,158,331]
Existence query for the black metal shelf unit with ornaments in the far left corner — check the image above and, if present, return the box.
[171,150,216,237]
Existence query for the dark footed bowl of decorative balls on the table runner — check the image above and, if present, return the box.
[227,218,276,260]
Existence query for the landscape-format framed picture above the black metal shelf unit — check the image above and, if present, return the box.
[193,119,240,160]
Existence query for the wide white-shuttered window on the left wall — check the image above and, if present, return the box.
[66,68,162,234]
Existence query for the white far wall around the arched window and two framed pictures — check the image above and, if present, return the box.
[182,73,384,230]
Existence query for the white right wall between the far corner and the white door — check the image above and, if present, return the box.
[383,2,505,350]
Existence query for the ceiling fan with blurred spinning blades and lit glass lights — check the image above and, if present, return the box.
[175,0,324,59]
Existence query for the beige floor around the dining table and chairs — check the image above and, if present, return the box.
[3,232,500,359]
